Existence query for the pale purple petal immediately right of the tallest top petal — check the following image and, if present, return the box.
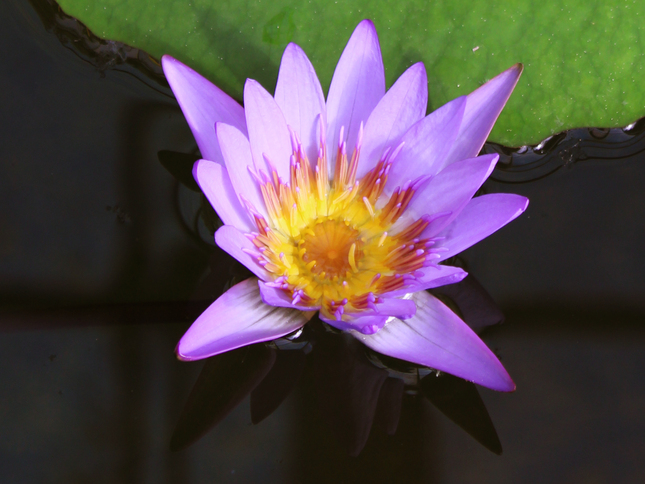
[358,62,428,177]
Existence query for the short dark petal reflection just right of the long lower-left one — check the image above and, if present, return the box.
[251,350,307,424]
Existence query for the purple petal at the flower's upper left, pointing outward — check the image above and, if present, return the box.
[161,55,246,162]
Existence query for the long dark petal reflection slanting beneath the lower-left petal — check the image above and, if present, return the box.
[170,344,276,450]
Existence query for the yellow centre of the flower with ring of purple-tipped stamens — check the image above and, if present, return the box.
[248,126,432,320]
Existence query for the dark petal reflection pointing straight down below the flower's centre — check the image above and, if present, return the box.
[312,334,387,456]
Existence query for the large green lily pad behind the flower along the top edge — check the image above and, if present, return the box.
[59,0,645,146]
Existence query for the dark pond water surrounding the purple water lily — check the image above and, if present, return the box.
[0,0,645,484]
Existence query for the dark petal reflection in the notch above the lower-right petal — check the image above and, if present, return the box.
[430,274,504,332]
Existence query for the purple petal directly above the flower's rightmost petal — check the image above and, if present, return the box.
[408,153,499,233]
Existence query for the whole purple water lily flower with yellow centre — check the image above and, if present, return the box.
[162,20,528,391]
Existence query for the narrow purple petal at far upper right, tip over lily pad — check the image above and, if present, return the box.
[445,64,524,164]
